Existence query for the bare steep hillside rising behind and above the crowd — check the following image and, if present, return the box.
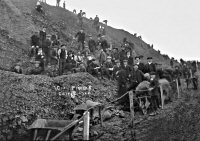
[0,0,172,69]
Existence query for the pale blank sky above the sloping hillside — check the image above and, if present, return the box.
[46,0,200,60]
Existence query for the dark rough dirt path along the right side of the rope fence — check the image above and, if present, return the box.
[92,86,200,141]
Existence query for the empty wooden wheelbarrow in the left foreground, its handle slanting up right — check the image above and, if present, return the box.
[29,118,83,141]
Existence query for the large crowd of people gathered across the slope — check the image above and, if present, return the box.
[11,0,198,117]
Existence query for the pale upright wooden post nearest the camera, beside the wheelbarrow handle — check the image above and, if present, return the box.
[83,111,90,141]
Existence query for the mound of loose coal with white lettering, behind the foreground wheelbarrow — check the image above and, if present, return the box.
[0,71,116,140]
